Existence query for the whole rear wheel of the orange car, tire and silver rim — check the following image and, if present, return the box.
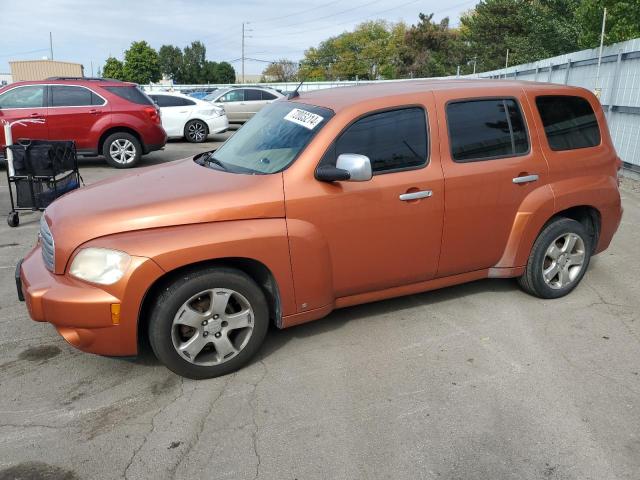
[518,218,593,299]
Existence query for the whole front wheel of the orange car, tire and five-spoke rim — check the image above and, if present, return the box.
[149,267,269,380]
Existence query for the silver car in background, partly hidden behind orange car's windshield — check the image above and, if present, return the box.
[205,87,284,123]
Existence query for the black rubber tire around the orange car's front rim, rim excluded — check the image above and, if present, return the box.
[149,268,269,380]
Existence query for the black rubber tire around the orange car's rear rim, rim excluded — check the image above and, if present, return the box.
[527,218,593,299]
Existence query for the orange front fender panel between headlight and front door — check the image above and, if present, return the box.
[80,218,296,315]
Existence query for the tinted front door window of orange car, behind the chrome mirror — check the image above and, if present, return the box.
[332,108,427,172]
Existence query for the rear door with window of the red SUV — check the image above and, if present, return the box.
[48,85,110,152]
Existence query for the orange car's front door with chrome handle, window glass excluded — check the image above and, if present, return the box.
[284,103,444,309]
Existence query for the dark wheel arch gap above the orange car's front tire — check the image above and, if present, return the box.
[137,257,282,351]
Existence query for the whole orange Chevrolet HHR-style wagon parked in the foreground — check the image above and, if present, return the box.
[16,80,622,378]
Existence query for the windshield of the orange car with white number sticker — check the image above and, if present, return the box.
[207,101,333,174]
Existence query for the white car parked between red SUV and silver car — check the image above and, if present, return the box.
[148,92,229,143]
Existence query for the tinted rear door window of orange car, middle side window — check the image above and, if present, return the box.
[447,98,529,163]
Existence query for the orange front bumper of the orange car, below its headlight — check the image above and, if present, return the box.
[16,246,163,356]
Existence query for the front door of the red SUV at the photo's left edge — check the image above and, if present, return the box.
[0,85,49,149]
